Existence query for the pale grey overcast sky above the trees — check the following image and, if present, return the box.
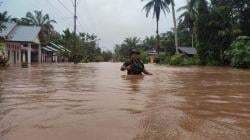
[0,0,186,50]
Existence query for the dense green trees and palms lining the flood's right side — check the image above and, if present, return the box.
[115,0,250,68]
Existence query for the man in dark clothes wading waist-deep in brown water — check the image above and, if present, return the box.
[121,49,153,75]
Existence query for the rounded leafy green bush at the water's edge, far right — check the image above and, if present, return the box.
[225,36,250,68]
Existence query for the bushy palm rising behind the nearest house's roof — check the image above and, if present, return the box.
[21,11,56,45]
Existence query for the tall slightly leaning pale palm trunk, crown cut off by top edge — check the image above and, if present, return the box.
[165,0,179,54]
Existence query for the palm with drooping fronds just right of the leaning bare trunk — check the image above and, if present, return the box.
[178,0,198,47]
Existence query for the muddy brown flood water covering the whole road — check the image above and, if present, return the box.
[0,63,250,140]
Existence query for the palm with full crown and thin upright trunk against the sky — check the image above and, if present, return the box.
[142,0,170,54]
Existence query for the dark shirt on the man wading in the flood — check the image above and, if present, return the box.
[123,59,145,75]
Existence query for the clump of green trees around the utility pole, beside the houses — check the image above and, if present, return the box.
[60,29,109,63]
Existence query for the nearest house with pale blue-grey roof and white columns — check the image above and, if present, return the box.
[0,23,42,64]
